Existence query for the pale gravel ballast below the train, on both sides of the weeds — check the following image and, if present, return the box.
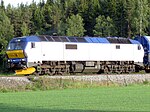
[0,74,150,88]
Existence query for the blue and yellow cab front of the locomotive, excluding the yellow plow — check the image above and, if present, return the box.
[6,38,27,69]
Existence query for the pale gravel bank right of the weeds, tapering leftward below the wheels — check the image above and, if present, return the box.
[44,74,150,85]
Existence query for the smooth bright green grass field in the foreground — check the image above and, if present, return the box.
[0,85,150,112]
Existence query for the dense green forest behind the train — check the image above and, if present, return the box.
[0,0,150,54]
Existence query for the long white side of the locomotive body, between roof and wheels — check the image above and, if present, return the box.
[25,41,144,63]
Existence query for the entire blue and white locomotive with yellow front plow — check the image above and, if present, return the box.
[6,35,145,75]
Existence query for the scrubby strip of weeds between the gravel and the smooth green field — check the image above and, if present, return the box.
[0,76,115,92]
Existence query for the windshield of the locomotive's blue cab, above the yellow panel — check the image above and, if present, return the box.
[7,39,26,50]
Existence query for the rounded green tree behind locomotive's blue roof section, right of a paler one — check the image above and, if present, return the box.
[93,15,116,37]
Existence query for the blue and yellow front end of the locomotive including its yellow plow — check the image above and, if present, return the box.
[6,37,35,74]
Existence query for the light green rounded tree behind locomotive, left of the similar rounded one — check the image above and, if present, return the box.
[67,14,85,37]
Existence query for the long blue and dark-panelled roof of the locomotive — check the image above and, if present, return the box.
[12,35,139,44]
